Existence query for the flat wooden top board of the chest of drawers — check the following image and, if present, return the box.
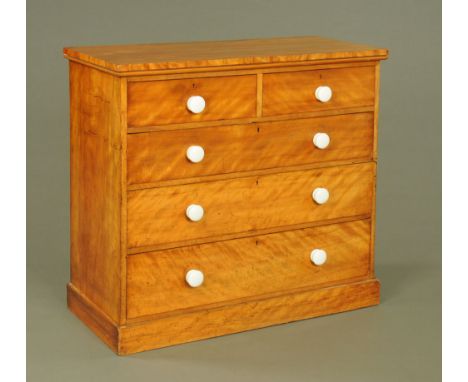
[64,36,388,73]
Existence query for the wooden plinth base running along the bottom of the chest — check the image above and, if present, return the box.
[67,279,380,355]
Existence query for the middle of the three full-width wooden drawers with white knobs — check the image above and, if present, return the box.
[127,162,375,248]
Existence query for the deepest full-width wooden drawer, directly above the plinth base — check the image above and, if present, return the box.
[127,220,370,318]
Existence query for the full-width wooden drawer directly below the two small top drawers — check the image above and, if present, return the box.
[127,113,374,184]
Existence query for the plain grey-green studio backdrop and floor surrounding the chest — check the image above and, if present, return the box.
[27,0,441,382]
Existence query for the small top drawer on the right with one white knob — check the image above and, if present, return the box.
[263,66,375,116]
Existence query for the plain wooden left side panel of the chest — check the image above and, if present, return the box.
[70,63,122,322]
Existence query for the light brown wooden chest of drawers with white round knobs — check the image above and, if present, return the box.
[64,37,387,354]
